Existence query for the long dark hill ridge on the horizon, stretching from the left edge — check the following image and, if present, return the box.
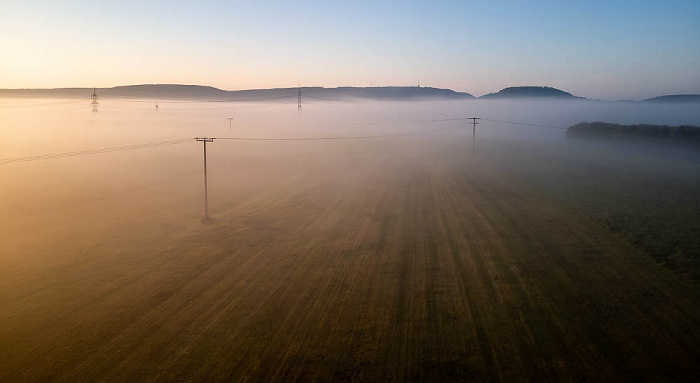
[0,84,474,101]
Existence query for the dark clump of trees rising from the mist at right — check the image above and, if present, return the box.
[566,122,700,144]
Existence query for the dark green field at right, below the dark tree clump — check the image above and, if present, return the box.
[488,140,700,284]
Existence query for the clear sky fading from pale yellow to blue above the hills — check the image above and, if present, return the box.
[0,0,700,99]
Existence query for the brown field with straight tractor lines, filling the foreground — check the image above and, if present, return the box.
[0,136,700,382]
